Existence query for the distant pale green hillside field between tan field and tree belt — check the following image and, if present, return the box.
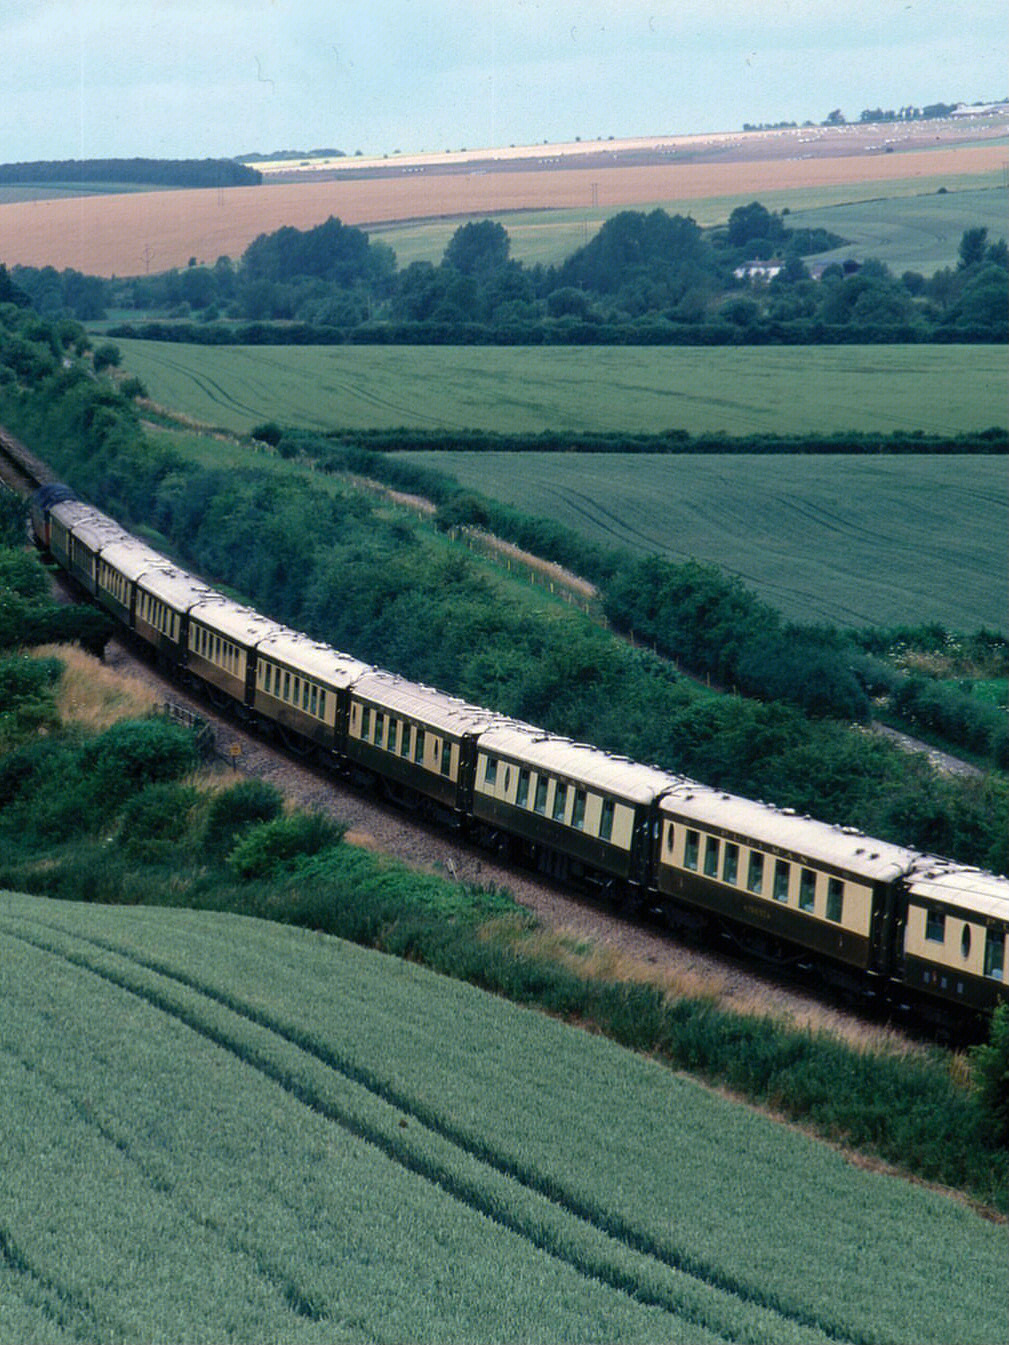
[367,174,1006,274]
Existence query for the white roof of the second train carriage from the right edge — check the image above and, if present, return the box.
[659,780,916,882]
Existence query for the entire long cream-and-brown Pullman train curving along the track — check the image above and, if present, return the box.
[28,482,1009,1022]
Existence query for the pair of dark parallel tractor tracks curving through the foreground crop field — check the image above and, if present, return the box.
[0,920,893,1341]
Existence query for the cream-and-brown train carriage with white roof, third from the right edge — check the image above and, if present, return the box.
[474,724,677,897]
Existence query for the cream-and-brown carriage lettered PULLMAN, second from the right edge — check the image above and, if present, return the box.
[655,783,915,976]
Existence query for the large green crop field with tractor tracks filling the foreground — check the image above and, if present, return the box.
[0,894,1006,1345]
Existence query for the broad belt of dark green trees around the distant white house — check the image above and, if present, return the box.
[11,202,1009,346]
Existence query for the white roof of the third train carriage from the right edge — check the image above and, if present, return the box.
[479,721,679,803]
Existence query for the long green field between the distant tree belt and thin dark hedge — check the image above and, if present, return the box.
[117,340,1009,436]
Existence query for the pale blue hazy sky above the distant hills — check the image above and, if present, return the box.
[0,0,1009,163]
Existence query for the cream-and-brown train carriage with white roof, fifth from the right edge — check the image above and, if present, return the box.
[252,627,371,755]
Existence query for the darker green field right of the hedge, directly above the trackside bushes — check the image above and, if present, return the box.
[402,452,1009,631]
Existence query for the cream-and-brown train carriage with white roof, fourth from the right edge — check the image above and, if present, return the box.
[347,671,502,819]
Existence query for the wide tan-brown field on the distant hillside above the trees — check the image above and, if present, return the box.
[0,143,1006,276]
